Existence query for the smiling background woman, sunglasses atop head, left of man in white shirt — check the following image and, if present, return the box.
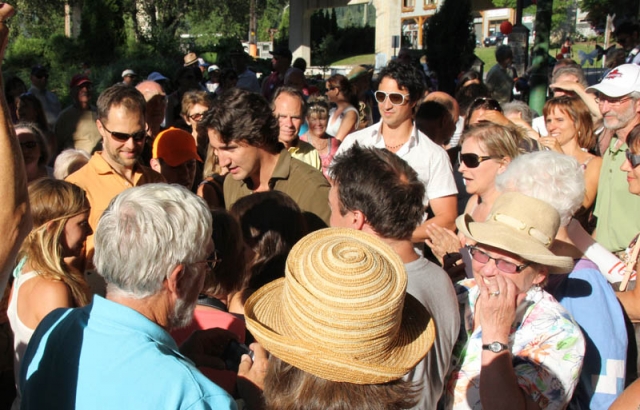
[300,96,340,178]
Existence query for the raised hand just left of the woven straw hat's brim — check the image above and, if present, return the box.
[236,343,269,410]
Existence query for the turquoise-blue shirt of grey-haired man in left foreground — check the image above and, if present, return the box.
[20,295,236,410]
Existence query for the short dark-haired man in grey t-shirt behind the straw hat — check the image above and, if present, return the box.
[329,144,460,409]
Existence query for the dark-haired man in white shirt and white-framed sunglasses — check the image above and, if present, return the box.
[336,61,458,247]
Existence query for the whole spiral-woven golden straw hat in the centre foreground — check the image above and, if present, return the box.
[245,228,435,384]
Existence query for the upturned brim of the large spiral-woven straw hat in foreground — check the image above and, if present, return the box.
[245,278,436,384]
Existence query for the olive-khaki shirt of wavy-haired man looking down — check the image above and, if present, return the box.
[224,149,331,230]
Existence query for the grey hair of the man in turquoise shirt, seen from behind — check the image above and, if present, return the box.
[93,184,212,299]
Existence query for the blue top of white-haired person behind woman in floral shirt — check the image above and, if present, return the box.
[547,259,628,409]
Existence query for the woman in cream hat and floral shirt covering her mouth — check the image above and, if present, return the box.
[443,192,585,410]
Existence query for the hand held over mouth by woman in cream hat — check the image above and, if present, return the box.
[475,274,526,343]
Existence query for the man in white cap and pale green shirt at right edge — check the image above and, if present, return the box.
[587,64,640,253]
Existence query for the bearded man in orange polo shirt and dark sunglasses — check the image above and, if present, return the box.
[66,84,165,260]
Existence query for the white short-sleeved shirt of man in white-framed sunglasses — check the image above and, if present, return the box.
[336,121,458,206]
